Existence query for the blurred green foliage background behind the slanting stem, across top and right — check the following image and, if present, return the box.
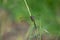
[0,0,60,39]
